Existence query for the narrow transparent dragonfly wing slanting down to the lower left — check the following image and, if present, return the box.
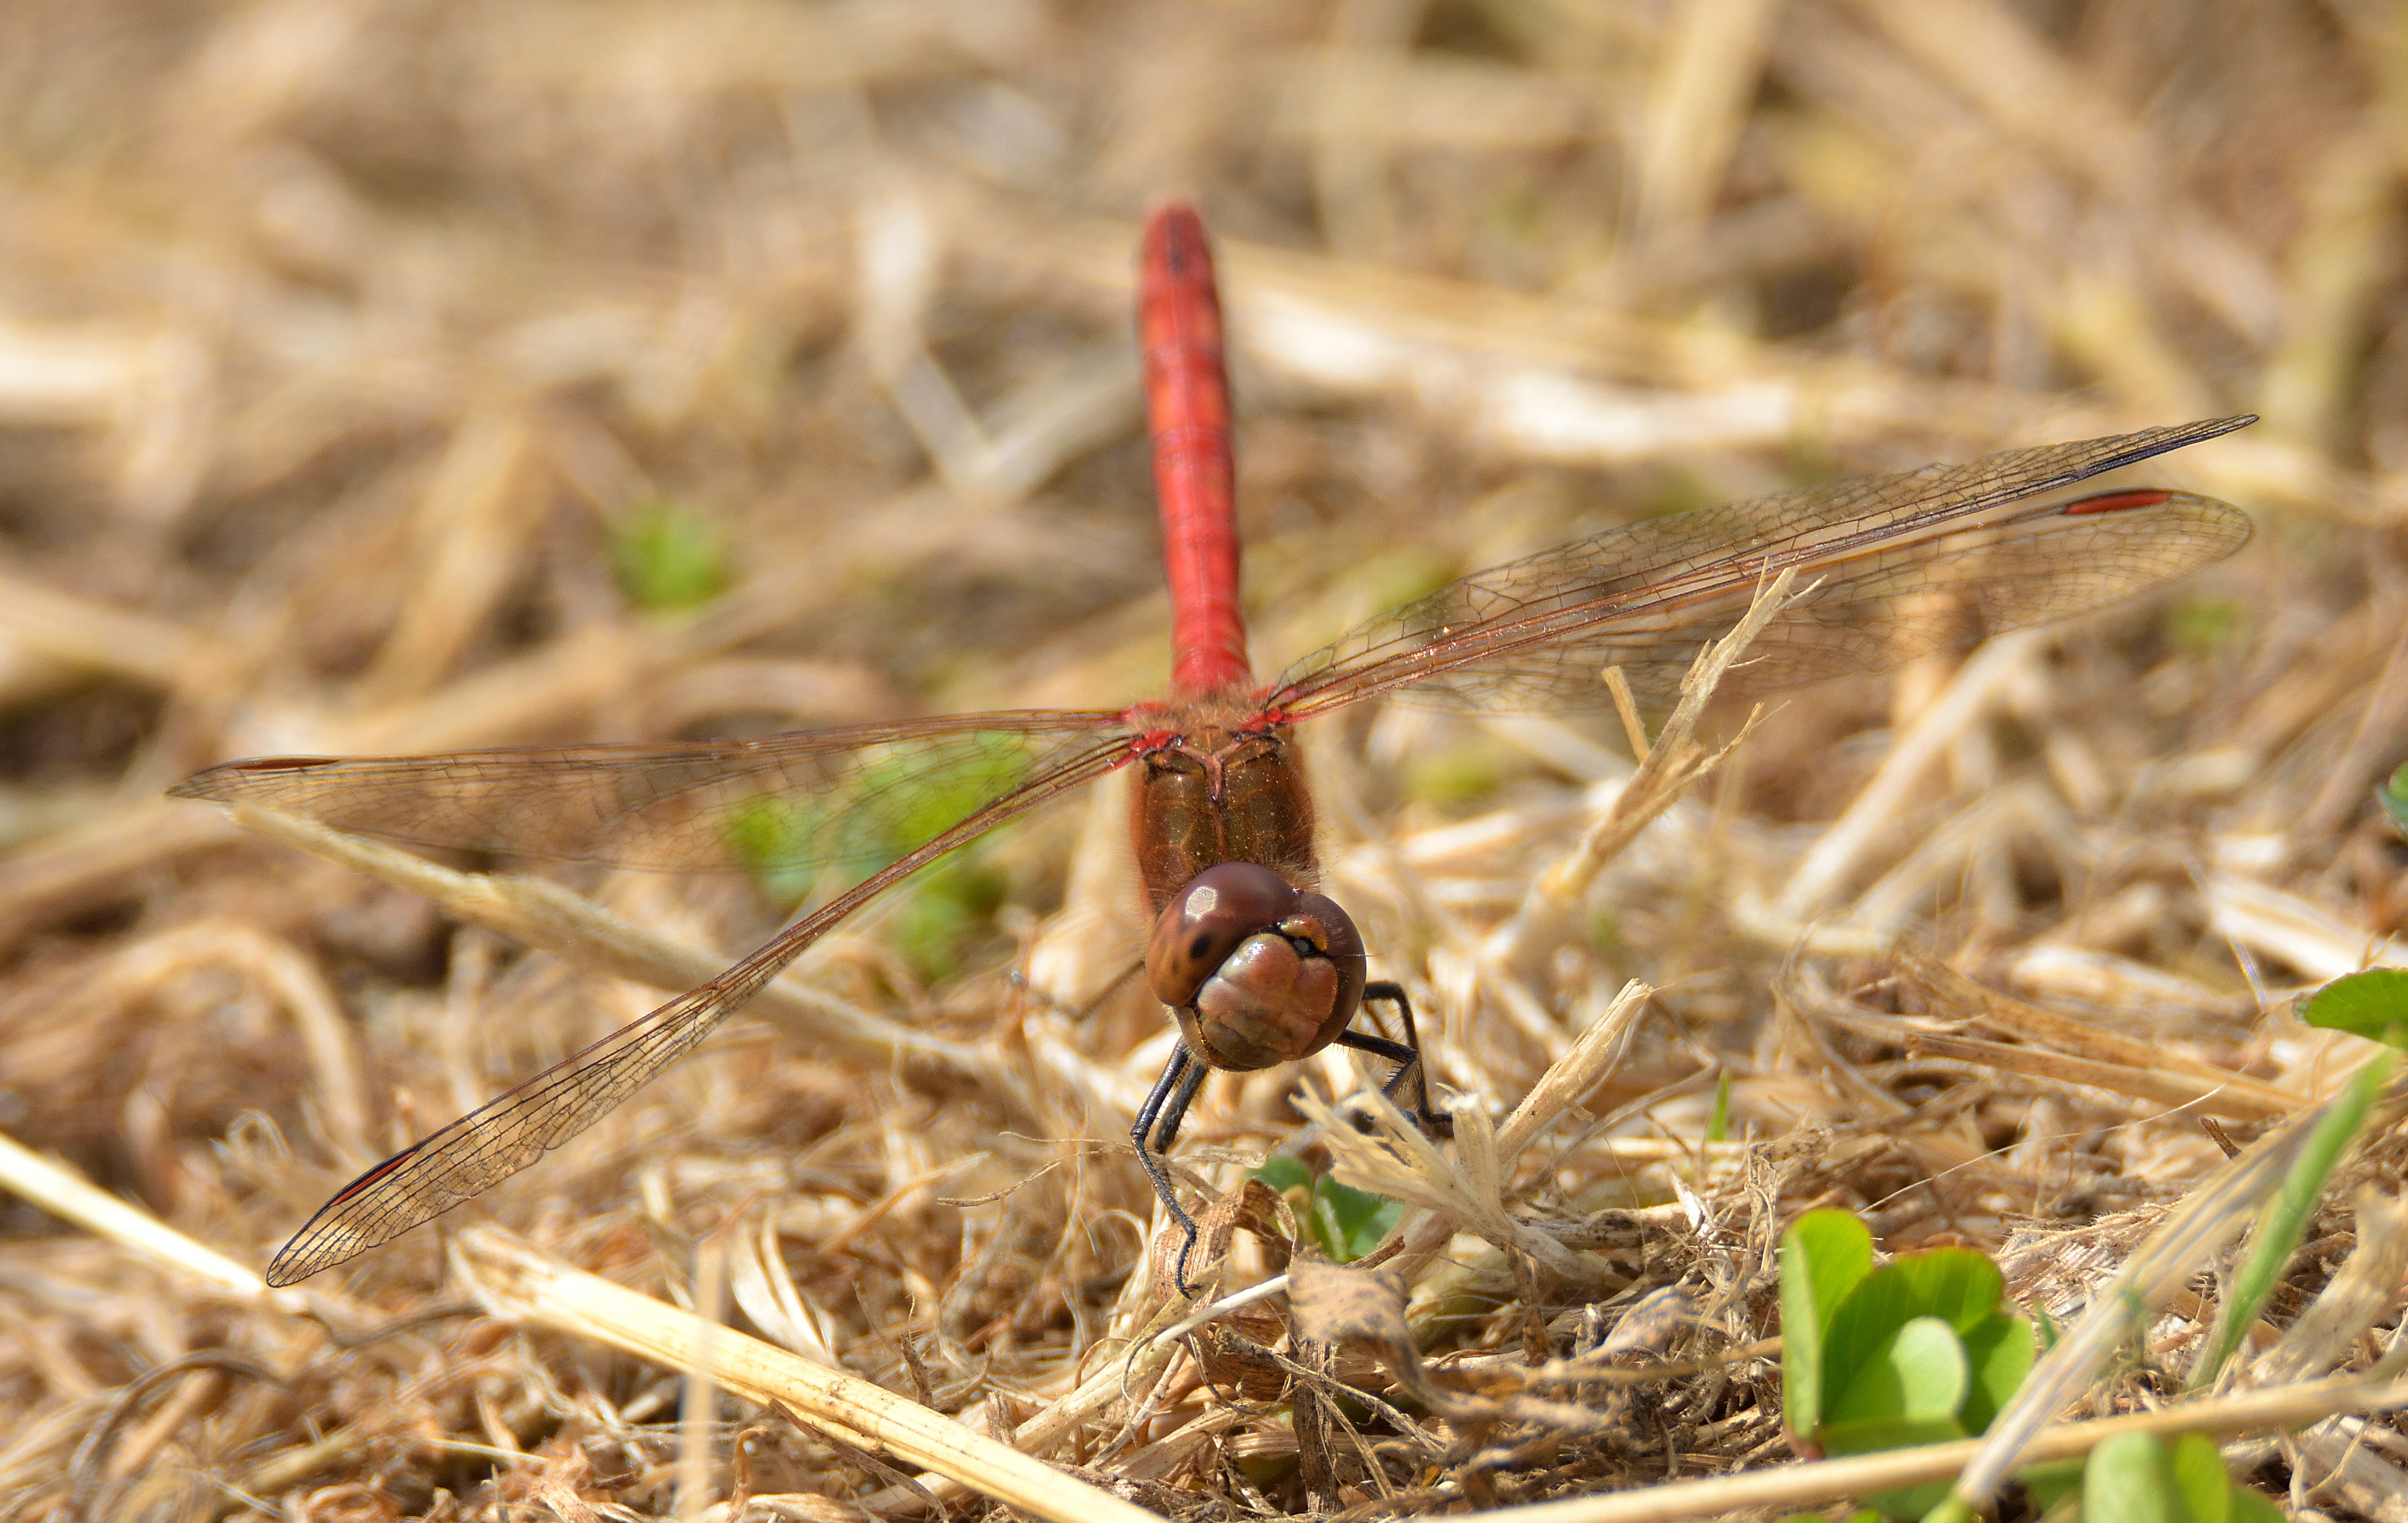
[267,731,1125,1285]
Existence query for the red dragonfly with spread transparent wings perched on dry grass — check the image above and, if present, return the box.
[171,204,2256,1292]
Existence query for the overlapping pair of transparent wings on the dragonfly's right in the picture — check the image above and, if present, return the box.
[1271,416,2254,714]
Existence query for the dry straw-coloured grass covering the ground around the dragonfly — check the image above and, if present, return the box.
[0,0,2408,1521]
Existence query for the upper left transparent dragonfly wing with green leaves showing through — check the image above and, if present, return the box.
[171,710,1125,871]
